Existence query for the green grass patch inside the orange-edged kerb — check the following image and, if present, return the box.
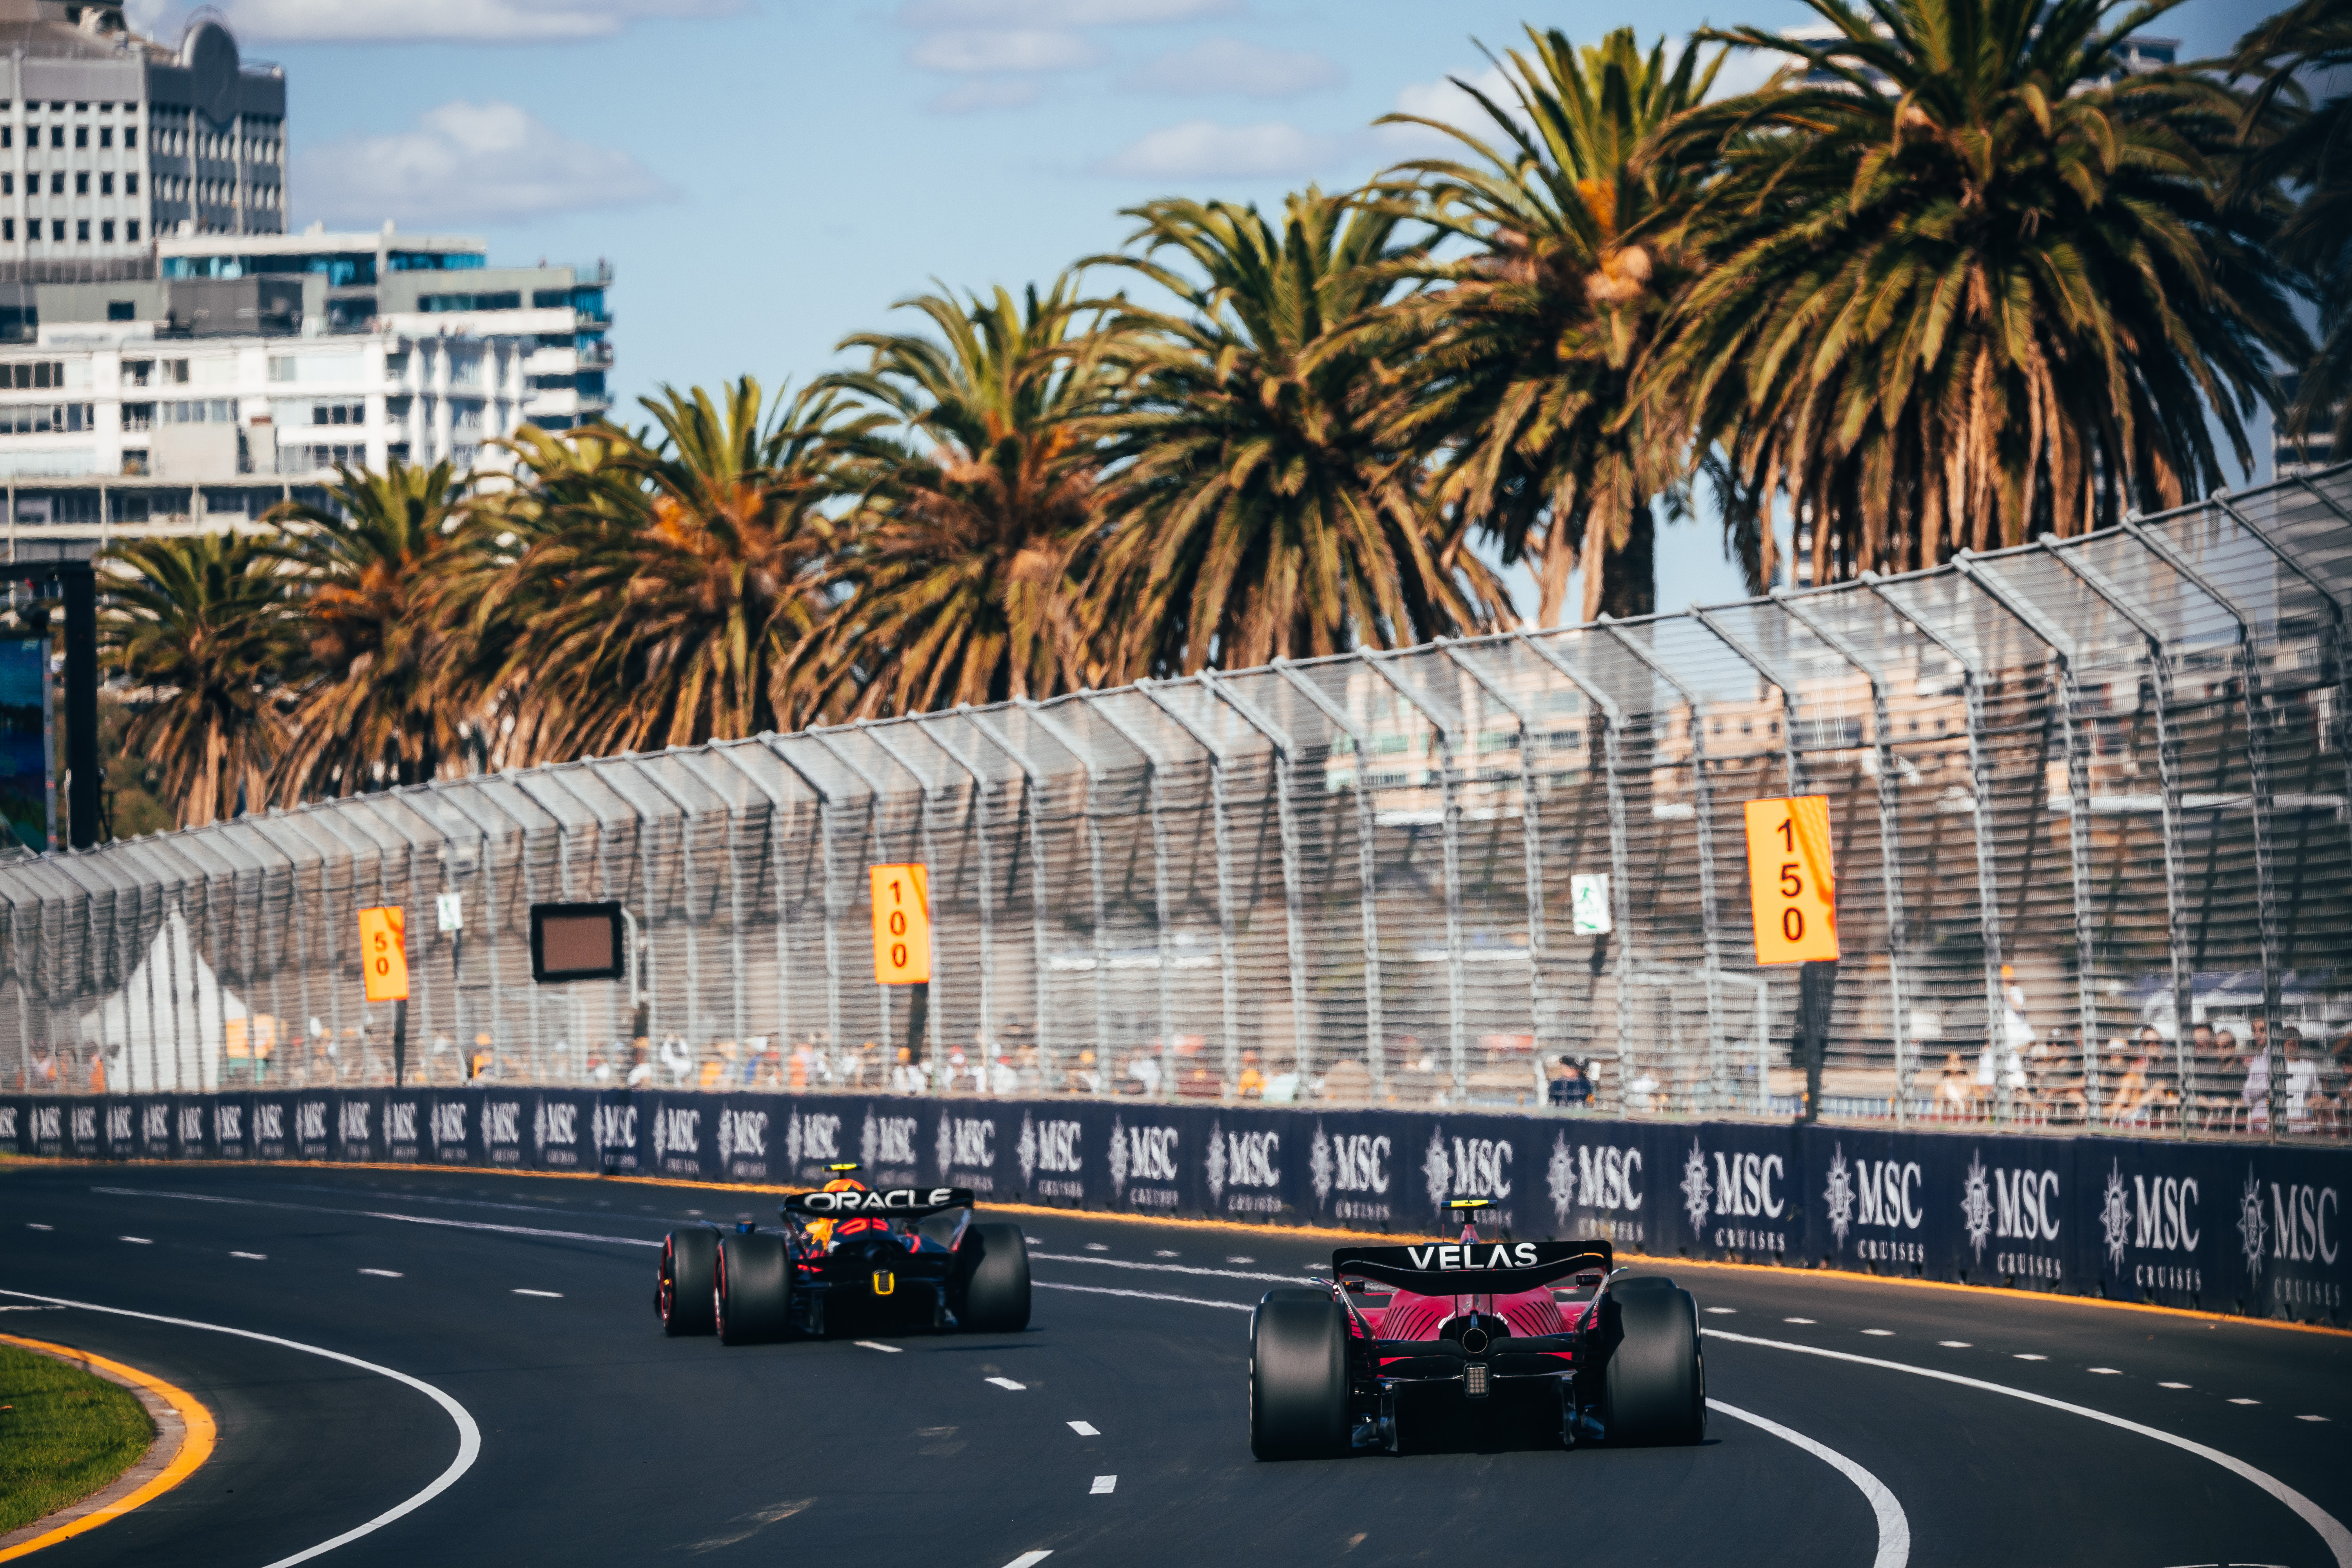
[0,1345,155,1535]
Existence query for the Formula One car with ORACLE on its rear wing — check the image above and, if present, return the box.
[654,1164,1030,1345]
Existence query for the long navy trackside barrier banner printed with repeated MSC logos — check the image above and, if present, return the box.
[0,1086,2352,1321]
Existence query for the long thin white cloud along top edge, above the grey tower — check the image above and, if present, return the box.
[127,0,748,45]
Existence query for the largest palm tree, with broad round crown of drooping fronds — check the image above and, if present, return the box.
[1649,0,2303,581]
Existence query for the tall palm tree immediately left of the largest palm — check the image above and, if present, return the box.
[1371,28,1722,625]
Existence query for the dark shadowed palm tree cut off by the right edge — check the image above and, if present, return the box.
[2230,0,2352,458]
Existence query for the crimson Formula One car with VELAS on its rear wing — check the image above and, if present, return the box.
[1249,1203,1708,1460]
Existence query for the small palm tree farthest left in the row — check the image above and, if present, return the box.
[99,534,287,828]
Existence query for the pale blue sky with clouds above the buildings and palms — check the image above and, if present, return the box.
[129,0,2274,609]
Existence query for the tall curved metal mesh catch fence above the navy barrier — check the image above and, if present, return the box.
[14,465,2352,1136]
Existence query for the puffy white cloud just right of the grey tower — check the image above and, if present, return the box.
[294,101,670,228]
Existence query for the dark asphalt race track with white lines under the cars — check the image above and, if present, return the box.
[0,1166,2352,1568]
